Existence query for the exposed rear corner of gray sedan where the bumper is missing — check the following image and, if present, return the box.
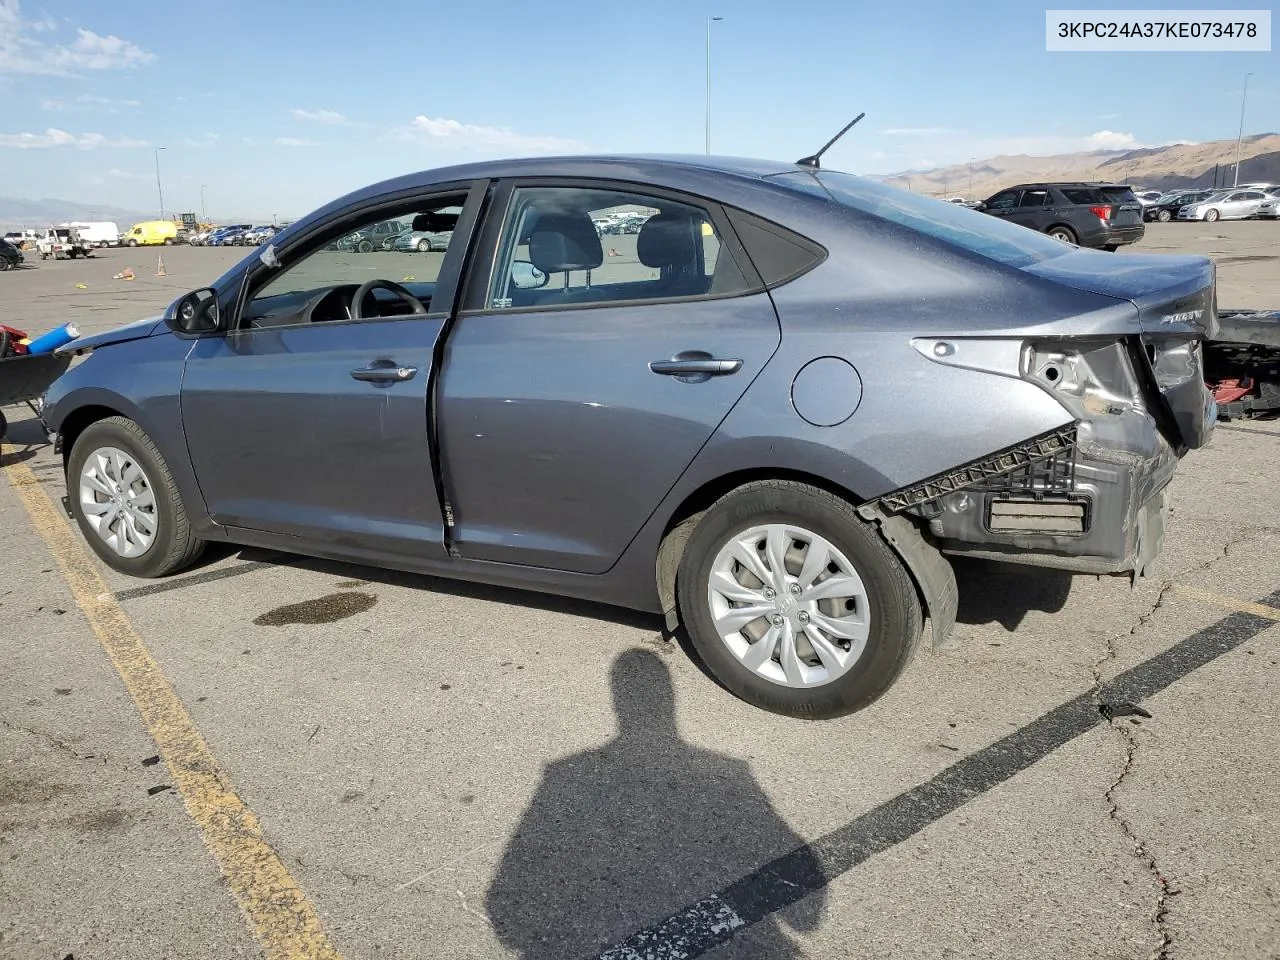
[881,410,1178,575]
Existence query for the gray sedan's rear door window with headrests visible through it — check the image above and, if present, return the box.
[486,187,759,310]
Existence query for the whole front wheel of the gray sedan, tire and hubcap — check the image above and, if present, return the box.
[67,417,205,577]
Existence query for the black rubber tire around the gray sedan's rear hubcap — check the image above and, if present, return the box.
[676,480,923,719]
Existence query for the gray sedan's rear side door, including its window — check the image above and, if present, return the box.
[440,186,780,573]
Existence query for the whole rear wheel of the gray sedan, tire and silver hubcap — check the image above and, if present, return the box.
[676,480,923,719]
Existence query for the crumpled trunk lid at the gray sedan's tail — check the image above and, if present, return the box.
[1024,251,1219,452]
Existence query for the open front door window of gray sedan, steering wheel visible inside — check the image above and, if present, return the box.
[241,195,466,328]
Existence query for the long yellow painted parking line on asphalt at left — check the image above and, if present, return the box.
[4,463,340,960]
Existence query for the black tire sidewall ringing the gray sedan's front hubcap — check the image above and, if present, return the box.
[67,419,178,577]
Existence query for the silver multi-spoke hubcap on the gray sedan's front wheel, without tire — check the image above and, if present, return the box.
[79,447,160,557]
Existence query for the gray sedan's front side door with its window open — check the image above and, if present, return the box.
[182,193,476,559]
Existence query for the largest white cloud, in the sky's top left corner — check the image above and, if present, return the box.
[0,0,156,76]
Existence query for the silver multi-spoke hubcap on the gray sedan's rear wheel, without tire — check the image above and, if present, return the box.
[707,524,870,687]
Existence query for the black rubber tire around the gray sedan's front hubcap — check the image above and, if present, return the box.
[67,417,205,577]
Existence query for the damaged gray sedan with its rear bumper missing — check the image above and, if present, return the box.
[44,157,1216,718]
